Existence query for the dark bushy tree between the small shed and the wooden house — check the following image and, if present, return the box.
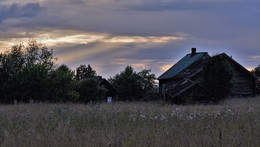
[109,66,157,101]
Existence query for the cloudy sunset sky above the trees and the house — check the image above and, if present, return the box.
[0,0,260,78]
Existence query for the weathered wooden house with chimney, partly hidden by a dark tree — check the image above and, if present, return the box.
[158,48,256,101]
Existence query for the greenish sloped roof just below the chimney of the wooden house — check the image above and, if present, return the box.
[158,52,210,80]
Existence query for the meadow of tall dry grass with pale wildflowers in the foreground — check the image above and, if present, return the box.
[0,97,260,147]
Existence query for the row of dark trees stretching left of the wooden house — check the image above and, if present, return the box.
[0,40,158,103]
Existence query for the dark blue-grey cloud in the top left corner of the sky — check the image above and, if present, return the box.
[0,3,42,22]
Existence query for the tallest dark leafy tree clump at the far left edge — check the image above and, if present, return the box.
[0,40,56,101]
